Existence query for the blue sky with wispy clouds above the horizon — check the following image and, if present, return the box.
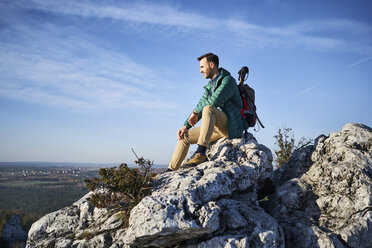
[0,0,372,165]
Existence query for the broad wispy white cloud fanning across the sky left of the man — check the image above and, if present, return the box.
[0,19,175,110]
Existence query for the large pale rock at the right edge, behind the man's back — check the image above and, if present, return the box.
[263,124,372,247]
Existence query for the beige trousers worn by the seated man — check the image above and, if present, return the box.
[168,105,228,170]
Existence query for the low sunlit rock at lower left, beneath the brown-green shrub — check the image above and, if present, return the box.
[26,192,123,248]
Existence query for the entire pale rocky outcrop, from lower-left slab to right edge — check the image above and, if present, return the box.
[27,124,372,248]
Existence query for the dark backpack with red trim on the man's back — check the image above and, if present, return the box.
[238,66,265,132]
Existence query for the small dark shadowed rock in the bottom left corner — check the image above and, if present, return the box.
[0,214,27,247]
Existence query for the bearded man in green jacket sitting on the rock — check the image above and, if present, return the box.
[167,53,246,172]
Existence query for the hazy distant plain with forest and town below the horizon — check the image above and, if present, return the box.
[0,162,166,231]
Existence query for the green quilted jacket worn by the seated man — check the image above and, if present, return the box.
[184,68,247,139]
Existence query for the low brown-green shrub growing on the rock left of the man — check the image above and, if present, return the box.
[84,149,154,226]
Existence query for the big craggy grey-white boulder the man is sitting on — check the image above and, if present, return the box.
[124,135,284,247]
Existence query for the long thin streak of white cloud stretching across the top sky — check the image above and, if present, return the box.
[5,0,372,54]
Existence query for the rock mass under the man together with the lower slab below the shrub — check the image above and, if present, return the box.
[27,135,284,248]
